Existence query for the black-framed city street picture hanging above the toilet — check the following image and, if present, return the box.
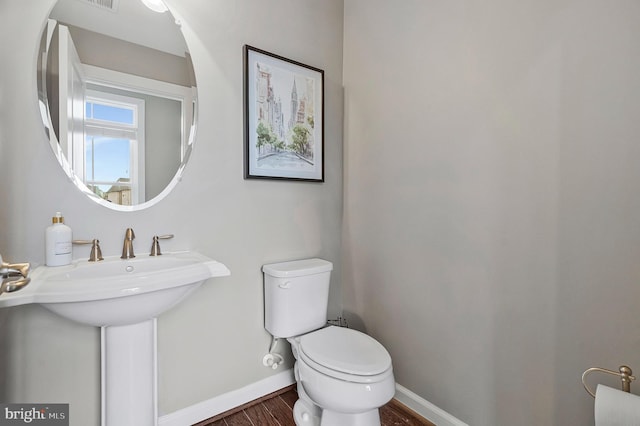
[244,45,324,182]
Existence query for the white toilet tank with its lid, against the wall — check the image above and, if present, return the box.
[262,259,333,338]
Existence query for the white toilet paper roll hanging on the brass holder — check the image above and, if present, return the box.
[594,385,640,426]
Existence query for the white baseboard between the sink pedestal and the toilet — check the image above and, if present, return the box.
[158,369,296,426]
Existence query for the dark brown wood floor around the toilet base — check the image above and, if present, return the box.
[194,385,435,426]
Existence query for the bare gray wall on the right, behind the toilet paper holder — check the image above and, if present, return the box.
[342,0,640,426]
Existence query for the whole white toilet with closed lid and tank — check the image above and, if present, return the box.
[262,259,395,426]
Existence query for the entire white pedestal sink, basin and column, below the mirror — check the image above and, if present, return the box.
[0,251,230,426]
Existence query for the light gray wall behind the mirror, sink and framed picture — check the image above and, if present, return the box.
[0,0,343,426]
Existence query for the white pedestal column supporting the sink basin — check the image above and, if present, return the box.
[101,318,158,426]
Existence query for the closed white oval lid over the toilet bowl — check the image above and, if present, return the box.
[299,326,391,376]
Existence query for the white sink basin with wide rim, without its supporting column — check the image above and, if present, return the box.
[0,251,230,327]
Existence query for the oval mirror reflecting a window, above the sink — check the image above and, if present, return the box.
[38,0,197,211]
